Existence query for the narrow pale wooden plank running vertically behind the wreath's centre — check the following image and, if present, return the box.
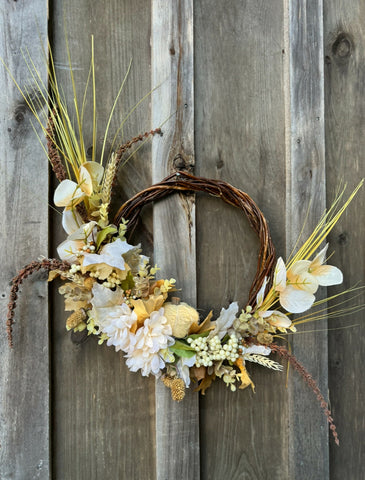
[152,0,200,480]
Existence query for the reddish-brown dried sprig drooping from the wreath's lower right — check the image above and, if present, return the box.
[270,343,340,445]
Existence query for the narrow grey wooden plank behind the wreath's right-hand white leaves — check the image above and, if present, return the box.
[286,1,329,479]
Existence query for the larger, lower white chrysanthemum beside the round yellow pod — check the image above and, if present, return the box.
[126,308,175,377]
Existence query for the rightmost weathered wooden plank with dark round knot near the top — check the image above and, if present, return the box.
[324,0,365,480]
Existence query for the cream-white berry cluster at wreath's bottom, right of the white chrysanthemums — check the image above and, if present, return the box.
[187,334,239,367]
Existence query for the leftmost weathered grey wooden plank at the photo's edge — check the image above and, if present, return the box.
[0,0,51,480]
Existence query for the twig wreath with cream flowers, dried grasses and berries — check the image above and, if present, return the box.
[7,45,362,443]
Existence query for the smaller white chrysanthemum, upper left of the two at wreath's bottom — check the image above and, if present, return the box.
[101,303,137,353]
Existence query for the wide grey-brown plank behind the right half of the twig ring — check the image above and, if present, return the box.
[194,0,290,480]
